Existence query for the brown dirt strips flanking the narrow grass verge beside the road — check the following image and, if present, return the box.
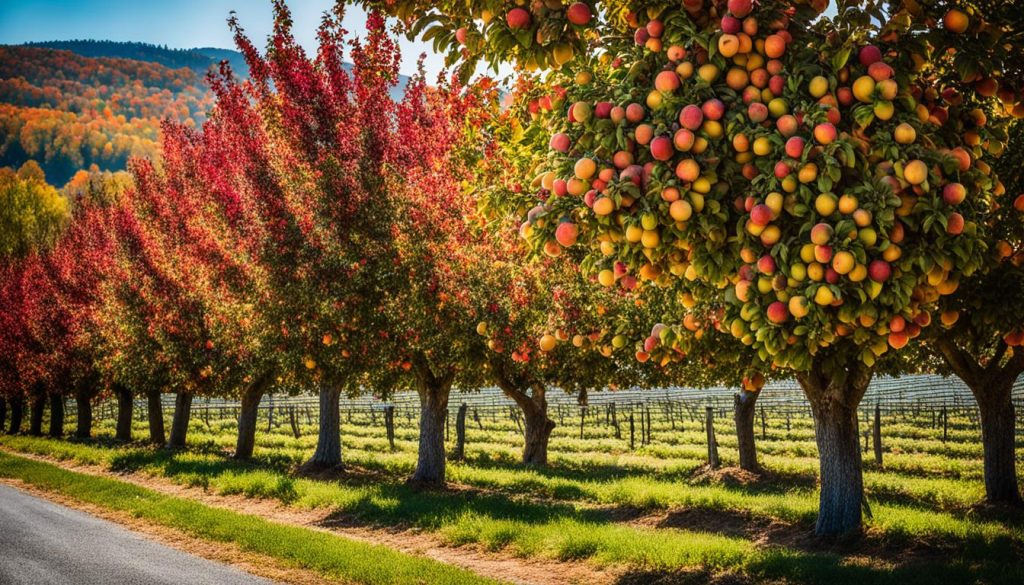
[0,447,623,585]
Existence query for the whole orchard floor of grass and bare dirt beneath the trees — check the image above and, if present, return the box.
[0,379,1024,583]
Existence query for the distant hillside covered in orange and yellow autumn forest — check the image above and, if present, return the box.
[0,46,212,184]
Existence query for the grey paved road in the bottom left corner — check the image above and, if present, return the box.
[0,485,269,585]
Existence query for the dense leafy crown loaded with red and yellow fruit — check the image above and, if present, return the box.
[520,0,1001,372]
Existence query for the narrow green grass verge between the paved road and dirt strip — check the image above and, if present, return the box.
[0,453,497,585]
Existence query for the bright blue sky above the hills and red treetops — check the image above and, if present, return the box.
[0,0,452,79]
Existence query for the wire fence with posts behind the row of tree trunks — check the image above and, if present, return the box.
[79,375,1024,431]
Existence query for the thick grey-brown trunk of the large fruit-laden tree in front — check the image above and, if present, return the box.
[797,360,871,536]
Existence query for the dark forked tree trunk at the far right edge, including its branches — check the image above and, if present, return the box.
[936,339,1024,506]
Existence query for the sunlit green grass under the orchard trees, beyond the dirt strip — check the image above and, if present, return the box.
[0,397,1024,585]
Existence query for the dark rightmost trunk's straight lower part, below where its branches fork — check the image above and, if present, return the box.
[971,380,1021,505]
